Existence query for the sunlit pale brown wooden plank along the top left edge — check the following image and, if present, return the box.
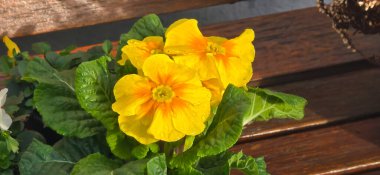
[0,0,237,37]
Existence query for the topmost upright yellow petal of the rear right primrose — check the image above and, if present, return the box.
[164,19,207,55]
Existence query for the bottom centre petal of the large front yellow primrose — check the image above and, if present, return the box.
[148,103,185,142]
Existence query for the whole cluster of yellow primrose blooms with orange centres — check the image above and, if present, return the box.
[112,19,255,144]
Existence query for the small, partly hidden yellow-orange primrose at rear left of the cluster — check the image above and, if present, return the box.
[119,36,164,69]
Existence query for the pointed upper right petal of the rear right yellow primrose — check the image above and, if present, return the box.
[223,29,255,62]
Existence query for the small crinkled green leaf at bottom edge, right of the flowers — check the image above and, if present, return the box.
[228,152,269,175]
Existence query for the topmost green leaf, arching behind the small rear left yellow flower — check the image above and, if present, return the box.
[117,14,165,58]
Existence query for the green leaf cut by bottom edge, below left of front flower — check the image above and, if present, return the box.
[71,153,147,175]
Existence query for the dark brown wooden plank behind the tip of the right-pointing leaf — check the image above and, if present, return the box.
[240,67,380,142]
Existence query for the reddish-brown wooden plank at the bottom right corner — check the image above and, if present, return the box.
[232,117,380,175]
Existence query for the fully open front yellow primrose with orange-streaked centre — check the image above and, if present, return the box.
[112,54,211,144]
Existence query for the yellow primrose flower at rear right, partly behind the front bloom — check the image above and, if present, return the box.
[164,19,255,88]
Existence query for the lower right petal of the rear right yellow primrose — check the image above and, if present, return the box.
[217,57,252,88]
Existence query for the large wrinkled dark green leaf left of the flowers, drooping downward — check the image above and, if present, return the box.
[24,59,103,138]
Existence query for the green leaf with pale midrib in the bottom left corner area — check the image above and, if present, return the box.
[18,140,75,175]
